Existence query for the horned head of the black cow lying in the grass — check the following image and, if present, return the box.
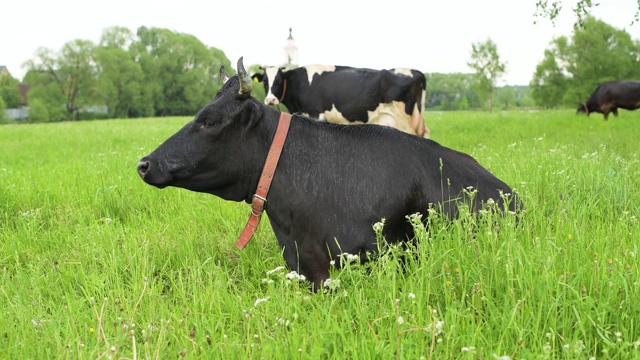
[137,58,262,201]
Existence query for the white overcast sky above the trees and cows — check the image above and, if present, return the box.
[0,0,640,85]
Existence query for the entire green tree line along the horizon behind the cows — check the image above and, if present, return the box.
[0,17,640,122]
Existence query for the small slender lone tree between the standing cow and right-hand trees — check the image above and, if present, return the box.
[467,39,506,111]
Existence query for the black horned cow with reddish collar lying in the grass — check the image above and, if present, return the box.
[137,58,519,290]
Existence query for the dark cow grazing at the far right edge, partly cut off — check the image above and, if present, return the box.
[576,80,640,120]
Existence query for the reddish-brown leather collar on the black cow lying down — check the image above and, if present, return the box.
[236,113,291,249]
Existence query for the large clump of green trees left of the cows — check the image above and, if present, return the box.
[0,27,232,121]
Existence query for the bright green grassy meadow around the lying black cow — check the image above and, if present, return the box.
[0,110,640,359]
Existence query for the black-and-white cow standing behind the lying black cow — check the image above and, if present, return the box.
[252,65,430,138]
